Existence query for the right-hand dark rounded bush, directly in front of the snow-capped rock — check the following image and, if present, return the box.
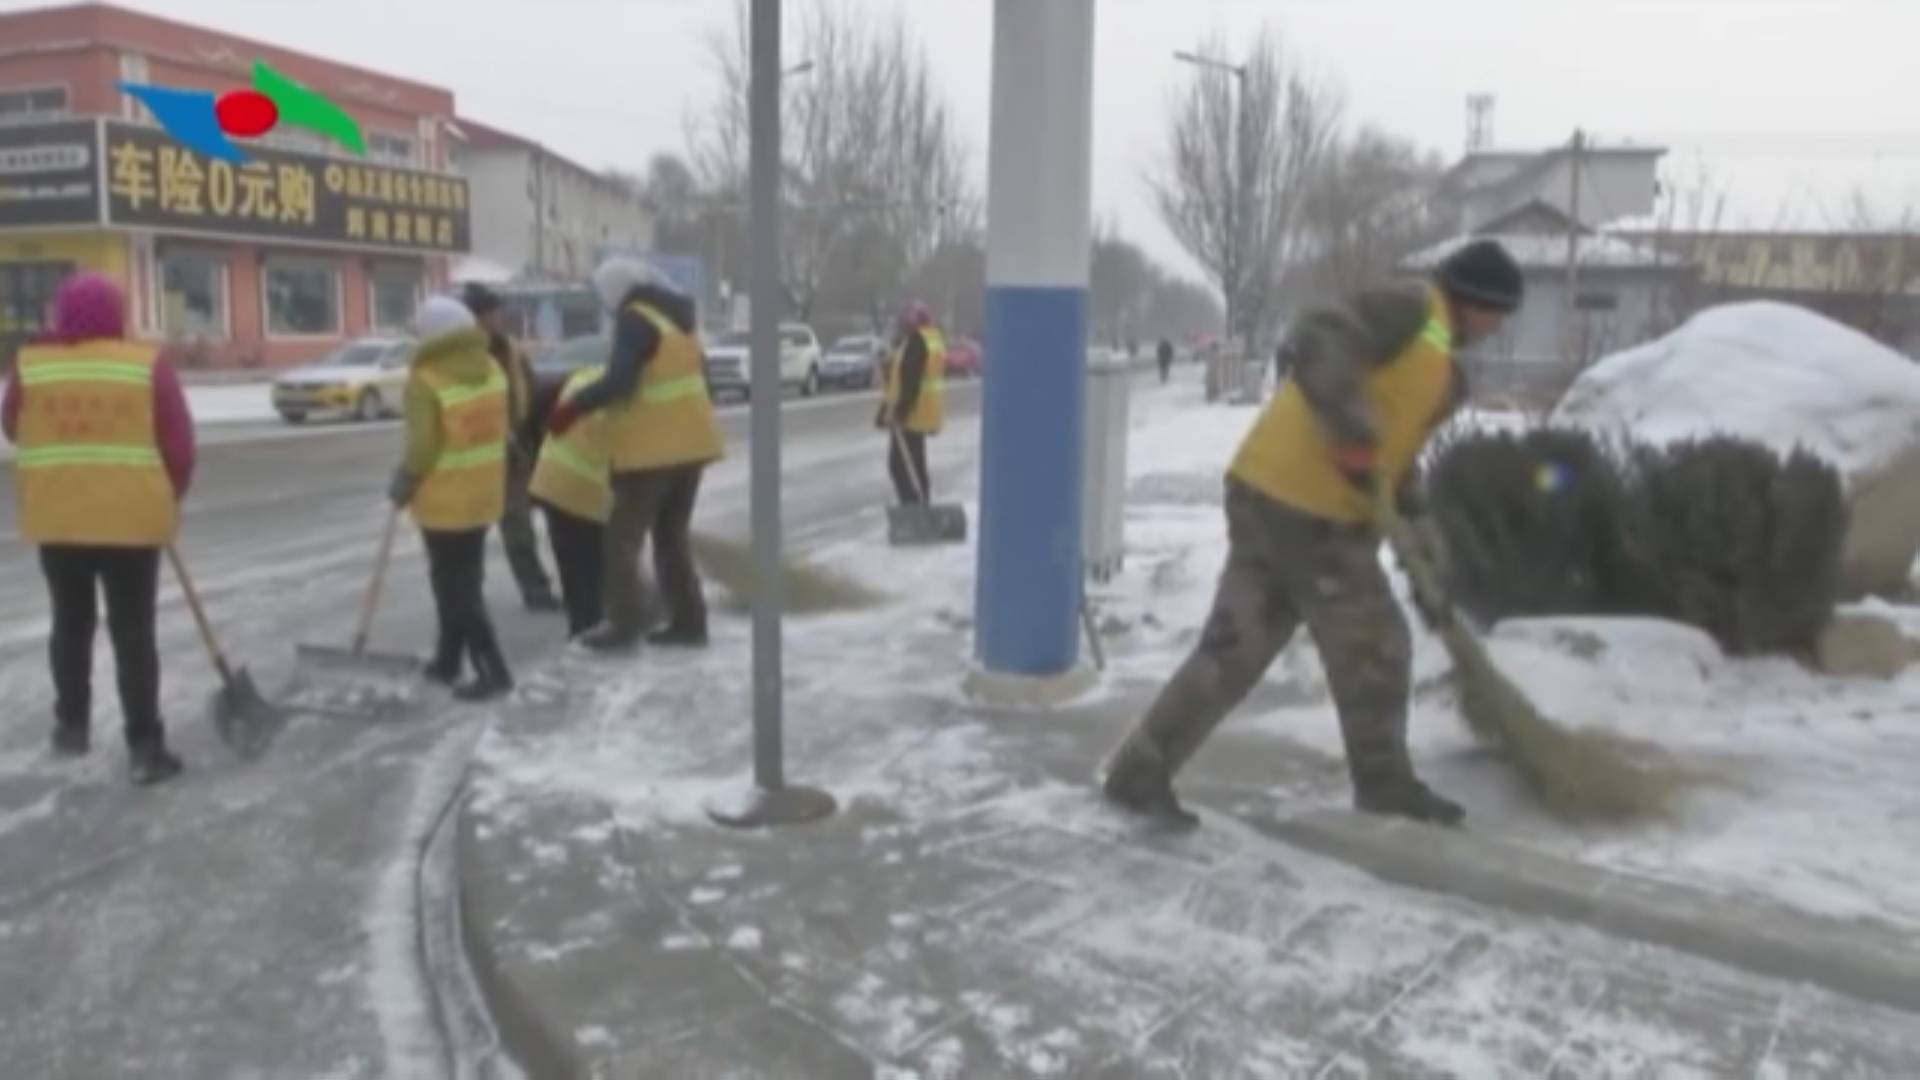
[1628,436,1847,655]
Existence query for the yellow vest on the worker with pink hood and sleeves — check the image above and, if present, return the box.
[13,340,180,548]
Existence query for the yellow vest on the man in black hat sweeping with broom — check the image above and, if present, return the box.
[1227,290,1453,525]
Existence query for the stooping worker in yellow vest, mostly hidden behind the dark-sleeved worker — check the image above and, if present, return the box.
[528,365,612,638]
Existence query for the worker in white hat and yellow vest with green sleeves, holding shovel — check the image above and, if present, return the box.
[388,296,513,701]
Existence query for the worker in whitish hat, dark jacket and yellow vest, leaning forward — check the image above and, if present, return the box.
[547,256,724,651]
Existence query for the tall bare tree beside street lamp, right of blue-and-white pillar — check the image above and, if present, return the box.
[1148,33,1340,352]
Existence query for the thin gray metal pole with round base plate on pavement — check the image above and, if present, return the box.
[707,0,833,826]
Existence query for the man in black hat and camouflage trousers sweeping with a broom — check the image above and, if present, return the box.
[1104,240,1523,826]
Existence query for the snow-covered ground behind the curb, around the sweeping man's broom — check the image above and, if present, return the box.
[1092,376,1920,926]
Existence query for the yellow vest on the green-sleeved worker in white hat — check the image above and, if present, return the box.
[411,363,507,532]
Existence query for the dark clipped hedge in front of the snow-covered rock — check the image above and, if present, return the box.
[1425,429,1847,655]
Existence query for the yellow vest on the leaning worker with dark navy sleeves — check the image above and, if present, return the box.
[607,300,726,473]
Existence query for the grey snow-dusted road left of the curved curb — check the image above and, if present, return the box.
[0,374,977,1078]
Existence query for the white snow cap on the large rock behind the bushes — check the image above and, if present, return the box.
[1551,302,1920,488]
